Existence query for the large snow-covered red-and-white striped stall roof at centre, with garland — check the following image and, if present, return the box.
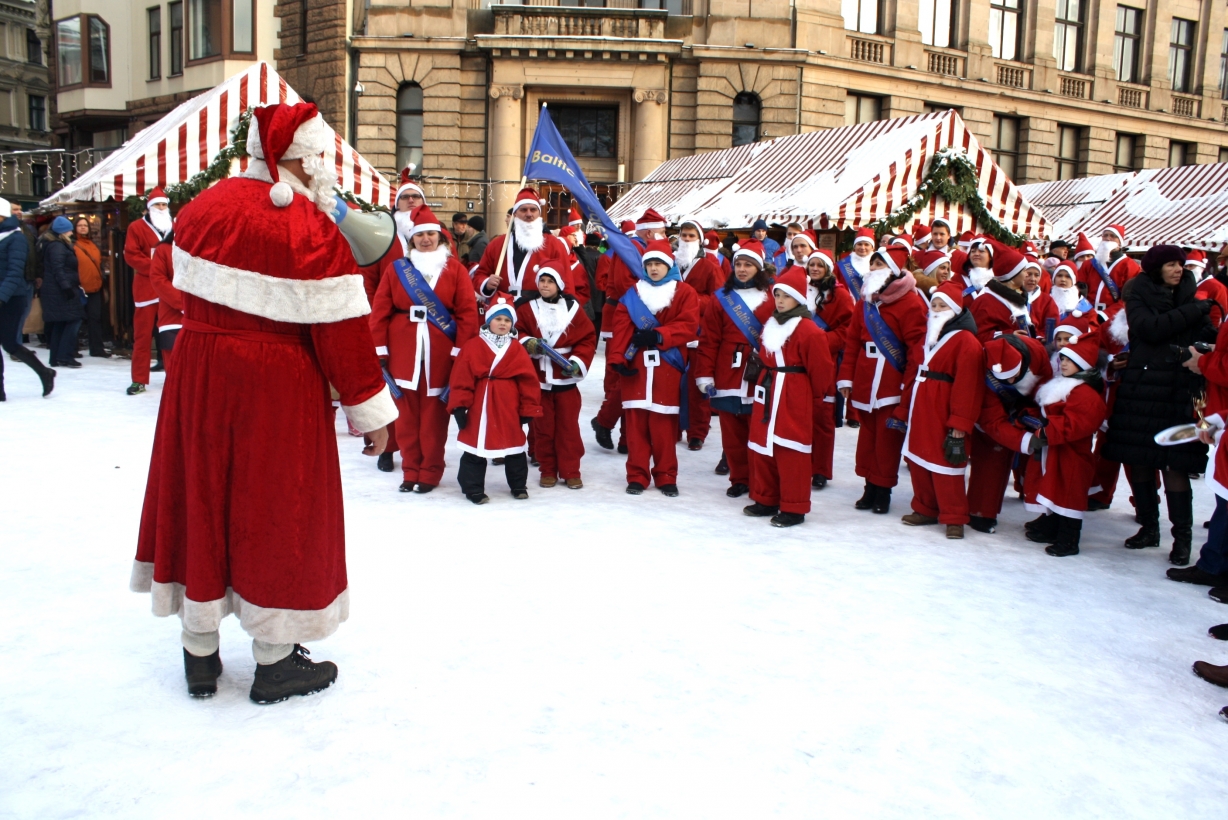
[610,110,1046,238]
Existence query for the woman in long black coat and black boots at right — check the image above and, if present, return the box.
[1104,246,1214,566]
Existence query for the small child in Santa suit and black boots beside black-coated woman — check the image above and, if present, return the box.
[1024,334,1106,556]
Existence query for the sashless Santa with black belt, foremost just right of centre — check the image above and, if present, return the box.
[742,268,835,527]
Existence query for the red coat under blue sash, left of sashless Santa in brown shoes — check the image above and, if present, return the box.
[839,290,927,412]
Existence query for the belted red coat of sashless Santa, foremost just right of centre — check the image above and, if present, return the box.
[747,317,835,455]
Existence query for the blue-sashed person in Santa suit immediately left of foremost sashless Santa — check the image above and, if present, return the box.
[693,239,775,498]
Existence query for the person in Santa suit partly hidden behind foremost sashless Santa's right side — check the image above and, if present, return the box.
[793,243,853,490]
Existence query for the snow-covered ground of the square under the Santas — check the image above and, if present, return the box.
[0,351,1228,820]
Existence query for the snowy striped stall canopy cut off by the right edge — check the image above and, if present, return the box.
[1070,162,1228,250]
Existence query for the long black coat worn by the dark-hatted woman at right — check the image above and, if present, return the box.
[1104,271,1214,473]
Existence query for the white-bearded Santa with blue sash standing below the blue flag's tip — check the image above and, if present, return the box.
[607,239,699,497]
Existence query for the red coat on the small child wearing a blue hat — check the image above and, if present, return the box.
[448,330,542,458]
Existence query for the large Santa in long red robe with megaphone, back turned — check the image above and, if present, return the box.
[131,103,397,702]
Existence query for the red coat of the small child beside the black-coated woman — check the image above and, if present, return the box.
[1027,376,1106,518]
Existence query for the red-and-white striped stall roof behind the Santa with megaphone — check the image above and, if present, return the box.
[42,61,393,206]
